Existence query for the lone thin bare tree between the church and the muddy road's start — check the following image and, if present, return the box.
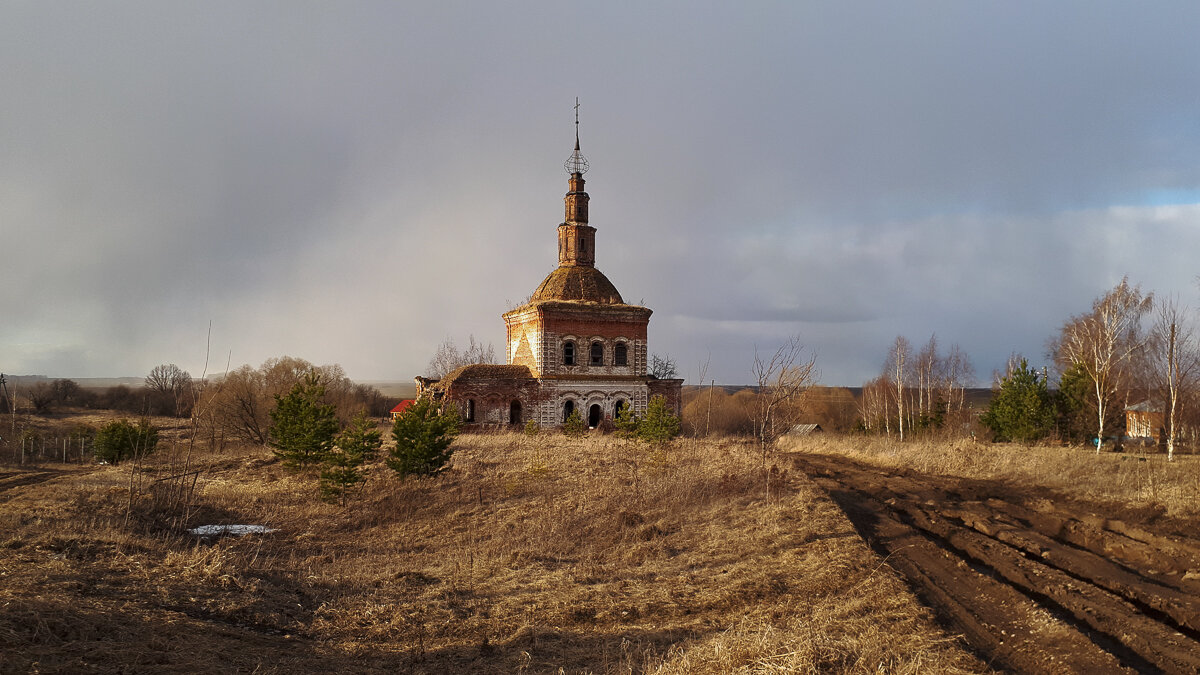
[751,335,817,454]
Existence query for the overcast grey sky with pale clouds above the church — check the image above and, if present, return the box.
[7,0,1200,386]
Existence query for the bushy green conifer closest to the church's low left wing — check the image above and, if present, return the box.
[388,396,460,478]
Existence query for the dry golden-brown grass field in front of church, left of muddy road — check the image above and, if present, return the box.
[0,420,986,674]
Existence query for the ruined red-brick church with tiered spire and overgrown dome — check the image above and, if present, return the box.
[416,114,683,429]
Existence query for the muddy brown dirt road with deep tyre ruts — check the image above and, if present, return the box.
[790,454,1200,673]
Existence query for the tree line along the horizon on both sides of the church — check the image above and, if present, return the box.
[0,271,1200,455]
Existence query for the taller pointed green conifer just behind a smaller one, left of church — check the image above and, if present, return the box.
[270,372,337,470]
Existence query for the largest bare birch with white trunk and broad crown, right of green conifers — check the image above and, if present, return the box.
[1057,277,1154,453]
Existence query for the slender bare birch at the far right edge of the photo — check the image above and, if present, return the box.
[1150,298,1200,461]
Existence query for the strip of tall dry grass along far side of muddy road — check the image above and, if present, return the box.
[780,435,1200,520]
